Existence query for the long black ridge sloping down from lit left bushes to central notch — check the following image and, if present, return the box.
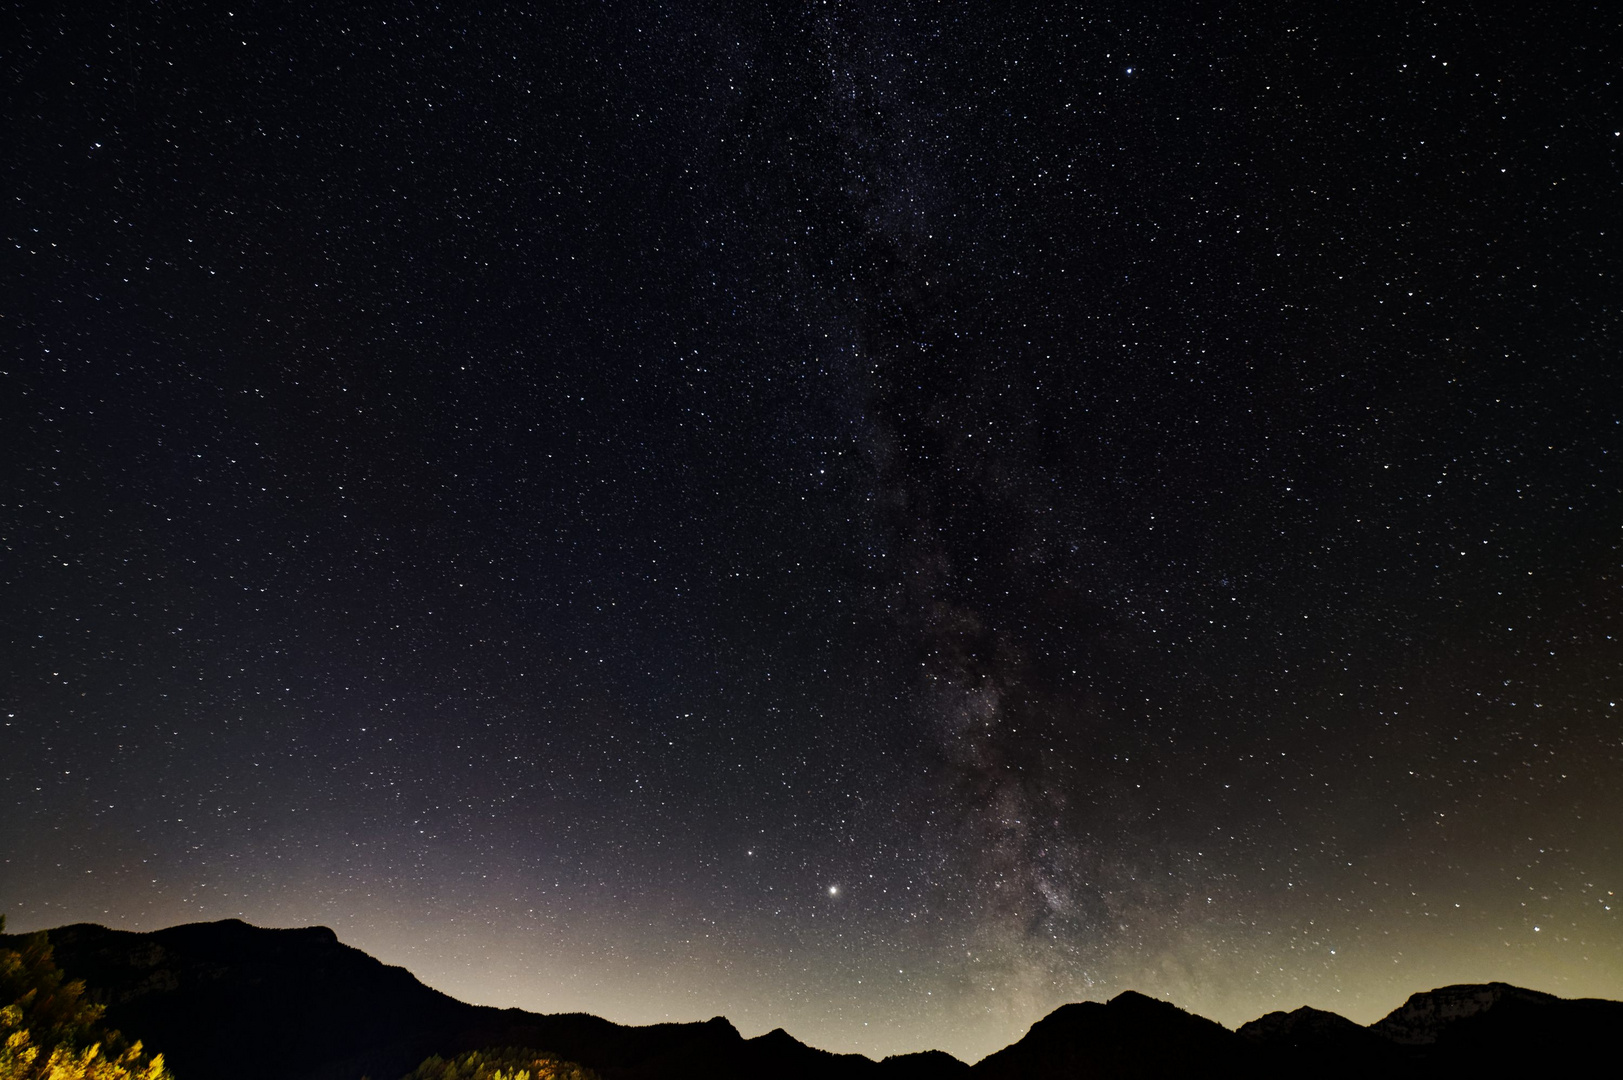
[0,919,967,1080]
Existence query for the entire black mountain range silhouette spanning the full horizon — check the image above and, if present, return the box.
[0,919,1623,1080]
